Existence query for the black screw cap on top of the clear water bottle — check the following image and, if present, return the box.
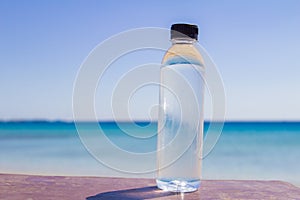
[171,24,198,40]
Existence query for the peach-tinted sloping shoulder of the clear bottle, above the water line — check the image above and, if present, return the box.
[162,44,204,66]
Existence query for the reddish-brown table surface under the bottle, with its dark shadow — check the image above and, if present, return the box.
[0,174,300,200]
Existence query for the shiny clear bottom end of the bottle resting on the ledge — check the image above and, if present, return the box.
[156,179,200,192]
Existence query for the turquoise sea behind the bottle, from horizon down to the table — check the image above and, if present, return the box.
[0,122,300,187]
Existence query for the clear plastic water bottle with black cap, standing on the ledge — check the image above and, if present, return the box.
[156,24,204,192]
